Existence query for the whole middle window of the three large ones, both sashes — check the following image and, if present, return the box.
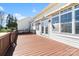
[61,12,72,33]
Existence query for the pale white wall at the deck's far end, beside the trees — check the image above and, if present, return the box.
[17,17,32,31]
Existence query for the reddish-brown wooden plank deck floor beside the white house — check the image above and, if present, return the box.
[5,34,79,56]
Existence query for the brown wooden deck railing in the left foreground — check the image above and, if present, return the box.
[0,31,16,56]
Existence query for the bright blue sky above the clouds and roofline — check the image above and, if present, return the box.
[0,3,48,19]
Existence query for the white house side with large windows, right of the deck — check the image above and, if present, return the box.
[35,3,79,48]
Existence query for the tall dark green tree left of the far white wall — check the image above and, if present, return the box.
[6,14,17,29]
